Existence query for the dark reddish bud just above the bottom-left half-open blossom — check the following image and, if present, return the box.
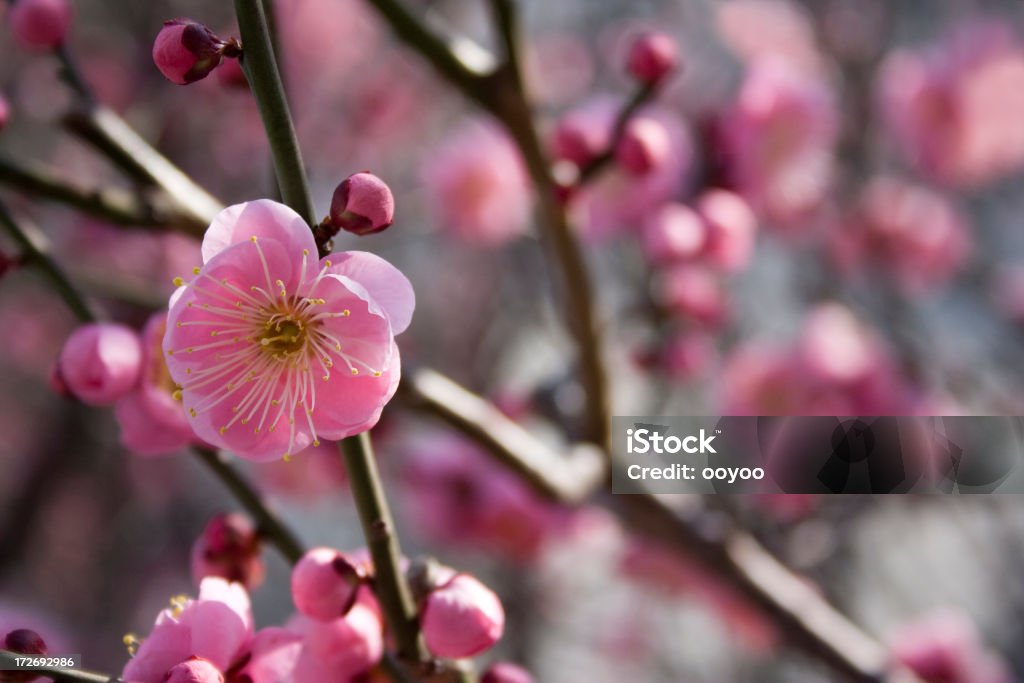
[191,513,263,591]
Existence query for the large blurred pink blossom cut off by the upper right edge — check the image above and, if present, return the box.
[878,20,1024,187]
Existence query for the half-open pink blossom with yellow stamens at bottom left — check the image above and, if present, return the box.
[122,577,253,683]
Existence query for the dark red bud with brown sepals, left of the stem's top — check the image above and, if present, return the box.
[153,19,240,85]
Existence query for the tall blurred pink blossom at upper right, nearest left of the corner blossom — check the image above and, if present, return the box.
[720,58,838,227]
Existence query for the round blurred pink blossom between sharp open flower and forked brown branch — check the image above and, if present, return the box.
[421,122,532,247]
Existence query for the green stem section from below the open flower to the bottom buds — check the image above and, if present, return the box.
[339,432,425,661]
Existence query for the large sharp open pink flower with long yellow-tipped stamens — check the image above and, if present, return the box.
[164,200,415,460]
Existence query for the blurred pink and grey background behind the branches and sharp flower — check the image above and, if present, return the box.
[0,0,1024,683]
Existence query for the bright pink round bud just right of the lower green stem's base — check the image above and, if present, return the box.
[421,573,505,658]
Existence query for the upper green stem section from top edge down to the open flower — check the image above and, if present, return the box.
[234,0,316,225]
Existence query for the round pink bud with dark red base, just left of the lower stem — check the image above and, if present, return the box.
[292,548,365,622]
